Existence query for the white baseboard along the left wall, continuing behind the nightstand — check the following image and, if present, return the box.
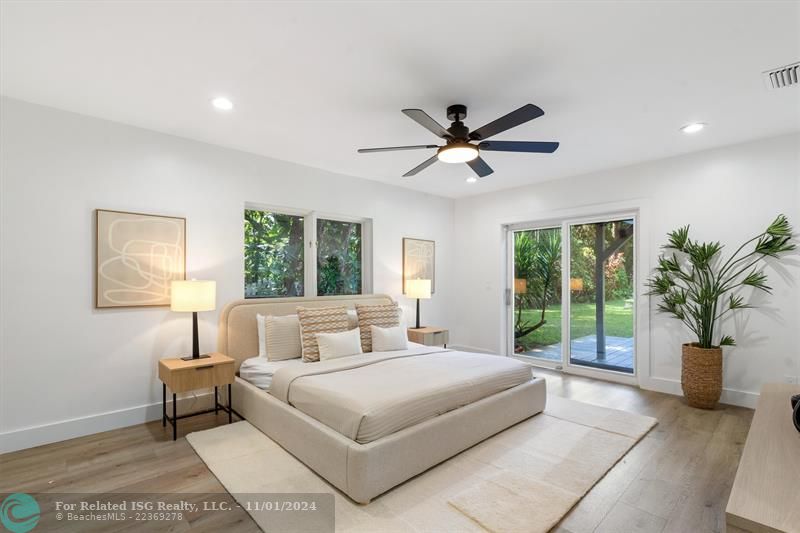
[0,391,219,453]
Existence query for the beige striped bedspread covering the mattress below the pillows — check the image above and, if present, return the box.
[269,346,532,444]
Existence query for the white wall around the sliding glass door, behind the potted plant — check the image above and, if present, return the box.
[452,131,800,405]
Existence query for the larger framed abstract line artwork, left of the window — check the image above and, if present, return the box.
[95,209,186,308]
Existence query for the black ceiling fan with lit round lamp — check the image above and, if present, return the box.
[358,104,558,178]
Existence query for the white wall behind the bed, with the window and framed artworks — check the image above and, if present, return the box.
[0,99,454,450]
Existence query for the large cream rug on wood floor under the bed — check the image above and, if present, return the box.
[186,395,657,533]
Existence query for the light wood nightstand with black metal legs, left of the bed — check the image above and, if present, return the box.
[158,352,234,440]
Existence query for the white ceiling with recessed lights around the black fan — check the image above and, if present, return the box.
[0,1,800,197]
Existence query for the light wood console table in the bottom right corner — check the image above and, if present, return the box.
[725,383,800,533]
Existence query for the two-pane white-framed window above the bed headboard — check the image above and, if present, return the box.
[244,208,372,298]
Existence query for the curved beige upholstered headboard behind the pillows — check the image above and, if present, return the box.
[217,294,394,371]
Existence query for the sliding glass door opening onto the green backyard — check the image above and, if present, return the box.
[508,215,636,374]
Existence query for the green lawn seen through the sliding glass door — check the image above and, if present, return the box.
[515,300,633,348]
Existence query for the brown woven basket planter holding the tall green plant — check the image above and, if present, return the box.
[681,344,722,409]
